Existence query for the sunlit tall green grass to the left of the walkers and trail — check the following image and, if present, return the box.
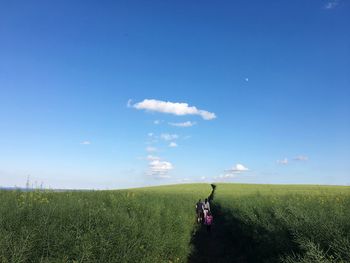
[0,185,211,262]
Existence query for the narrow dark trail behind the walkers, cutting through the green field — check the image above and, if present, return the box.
[188,185,248,263]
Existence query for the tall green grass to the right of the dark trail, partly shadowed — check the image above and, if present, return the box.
[215,184,350,263]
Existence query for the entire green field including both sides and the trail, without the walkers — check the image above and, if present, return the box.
[0,184,350,262]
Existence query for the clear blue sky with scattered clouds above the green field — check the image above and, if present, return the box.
[0,0,350,189]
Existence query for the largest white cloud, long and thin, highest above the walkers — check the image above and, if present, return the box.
[132,99,216,120]
